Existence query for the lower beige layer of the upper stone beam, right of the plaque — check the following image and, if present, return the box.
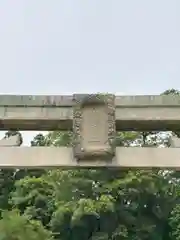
[116,106,180,131]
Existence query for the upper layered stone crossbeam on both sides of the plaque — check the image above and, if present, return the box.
[0,95,180,131]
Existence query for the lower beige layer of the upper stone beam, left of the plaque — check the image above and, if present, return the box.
[0,106,73,131]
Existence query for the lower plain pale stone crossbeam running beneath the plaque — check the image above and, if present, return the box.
[0,147,180,170]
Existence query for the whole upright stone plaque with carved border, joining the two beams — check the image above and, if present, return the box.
[73,94,115,161]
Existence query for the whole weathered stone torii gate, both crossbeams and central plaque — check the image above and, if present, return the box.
[0,94,180,169]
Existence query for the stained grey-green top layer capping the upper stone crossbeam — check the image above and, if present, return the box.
[0,94,180,107]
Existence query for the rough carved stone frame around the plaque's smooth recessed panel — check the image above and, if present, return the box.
[73,94,116,161]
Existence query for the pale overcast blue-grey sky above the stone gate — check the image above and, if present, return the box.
[0,0,180,144]
